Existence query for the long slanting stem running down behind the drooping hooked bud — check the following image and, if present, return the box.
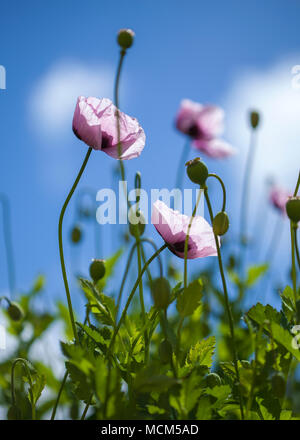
[203,186,244,420]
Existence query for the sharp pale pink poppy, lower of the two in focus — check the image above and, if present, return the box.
[151,200,217,259]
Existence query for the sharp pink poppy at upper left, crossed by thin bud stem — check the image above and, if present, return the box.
[73,96,145,159]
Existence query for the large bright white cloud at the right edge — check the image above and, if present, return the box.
[224,55,300,188]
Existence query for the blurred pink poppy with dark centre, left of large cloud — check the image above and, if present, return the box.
[176,99,236,159]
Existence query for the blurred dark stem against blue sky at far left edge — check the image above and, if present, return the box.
[0,193,15,297]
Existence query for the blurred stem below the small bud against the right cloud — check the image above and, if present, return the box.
[239,130,256,273]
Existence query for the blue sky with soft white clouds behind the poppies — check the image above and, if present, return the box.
[0,0,300,312]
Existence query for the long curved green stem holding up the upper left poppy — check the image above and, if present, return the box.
[58,147,92,343]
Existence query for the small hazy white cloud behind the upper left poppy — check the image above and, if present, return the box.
[29,60,114,139]
